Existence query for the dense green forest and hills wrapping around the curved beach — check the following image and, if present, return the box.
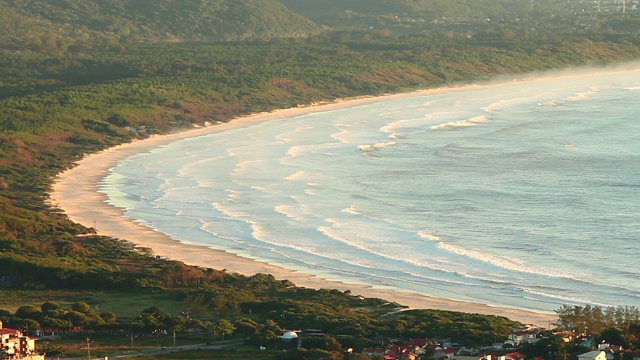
[0,0,640,359]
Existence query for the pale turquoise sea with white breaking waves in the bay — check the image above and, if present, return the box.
[100,67,640,312]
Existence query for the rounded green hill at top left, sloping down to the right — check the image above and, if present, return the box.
[0,0,321,46]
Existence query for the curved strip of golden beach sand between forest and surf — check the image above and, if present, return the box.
[50,89,557,327]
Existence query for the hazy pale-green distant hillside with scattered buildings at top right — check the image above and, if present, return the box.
[280,0,640,36]
